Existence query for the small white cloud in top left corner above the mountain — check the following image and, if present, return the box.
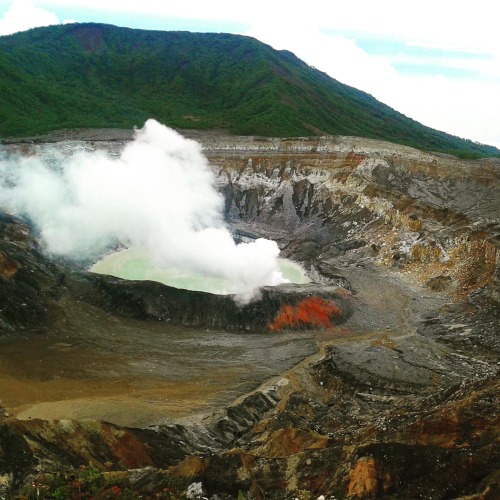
[0,0,59,35]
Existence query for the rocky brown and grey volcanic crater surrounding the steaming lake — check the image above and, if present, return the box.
[0,133,500,498]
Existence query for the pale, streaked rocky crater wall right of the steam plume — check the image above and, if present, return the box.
[207,138,500,298]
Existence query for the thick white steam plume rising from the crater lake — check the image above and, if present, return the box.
[0,120,286,301]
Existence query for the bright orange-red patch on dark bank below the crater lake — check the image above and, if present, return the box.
[267,297,342,331]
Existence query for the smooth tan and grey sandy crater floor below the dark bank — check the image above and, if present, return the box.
[0,296,332,426]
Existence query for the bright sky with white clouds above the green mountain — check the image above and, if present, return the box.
[0,0,500,148]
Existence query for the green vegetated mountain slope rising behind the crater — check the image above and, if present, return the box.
[0,24,500,157]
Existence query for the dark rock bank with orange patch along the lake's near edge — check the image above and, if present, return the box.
[65,272,352,331]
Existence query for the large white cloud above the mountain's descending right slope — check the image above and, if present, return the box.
[245,8,500,148]
